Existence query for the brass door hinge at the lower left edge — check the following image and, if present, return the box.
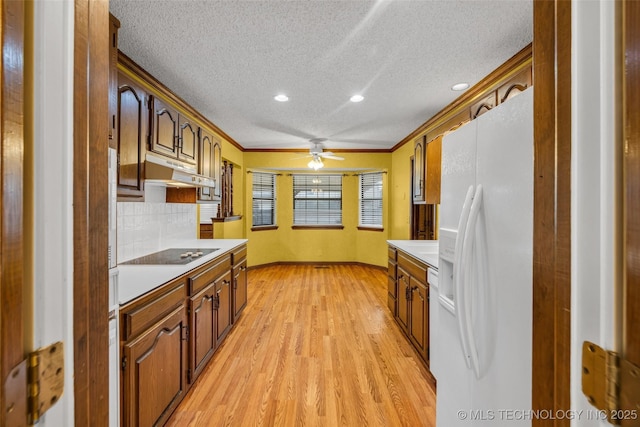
[4,342,64,425]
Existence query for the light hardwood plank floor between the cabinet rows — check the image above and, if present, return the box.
[167,265,435,427]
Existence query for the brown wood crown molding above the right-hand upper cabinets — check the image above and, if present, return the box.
[391,44,533,152]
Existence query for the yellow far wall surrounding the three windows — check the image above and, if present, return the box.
[244,152,391,266]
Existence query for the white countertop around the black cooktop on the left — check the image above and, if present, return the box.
[118,239,247,305]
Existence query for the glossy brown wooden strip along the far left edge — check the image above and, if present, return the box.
[0,0,27,425]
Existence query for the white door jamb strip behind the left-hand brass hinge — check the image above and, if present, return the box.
[33,0,74,426]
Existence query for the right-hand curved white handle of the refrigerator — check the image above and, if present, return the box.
[462,185,482,378]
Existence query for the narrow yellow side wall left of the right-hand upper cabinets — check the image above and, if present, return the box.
[389,142,413,240]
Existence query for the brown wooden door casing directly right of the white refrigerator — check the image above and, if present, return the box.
[532,0,571,426]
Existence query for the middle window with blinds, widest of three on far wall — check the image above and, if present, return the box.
[293,174,342,226]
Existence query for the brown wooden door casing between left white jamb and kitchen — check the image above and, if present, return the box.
[73,0,109,426]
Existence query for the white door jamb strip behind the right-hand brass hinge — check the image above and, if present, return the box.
[571,0,617,426]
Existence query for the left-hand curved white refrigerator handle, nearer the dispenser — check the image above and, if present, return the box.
[453,185,474,368]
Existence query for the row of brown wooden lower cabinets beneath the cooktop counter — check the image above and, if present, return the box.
[120,245,247,427]
